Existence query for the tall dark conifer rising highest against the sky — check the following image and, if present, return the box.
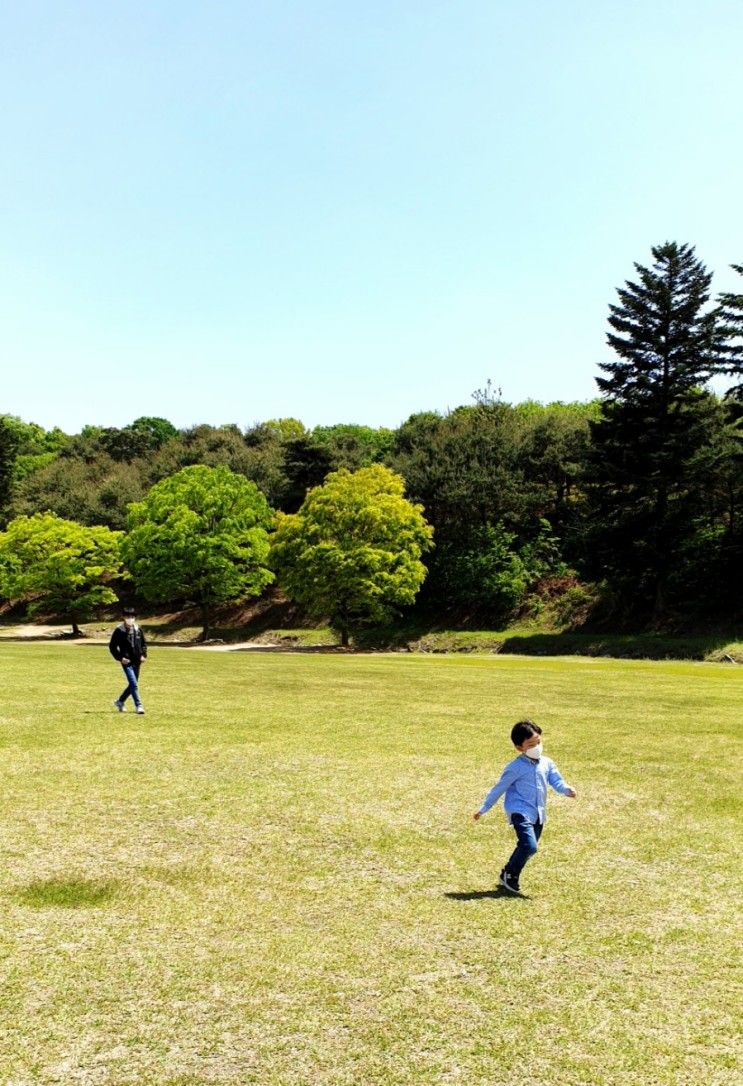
[591,242,725,620]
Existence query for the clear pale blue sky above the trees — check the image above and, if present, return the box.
[0,0,743,431]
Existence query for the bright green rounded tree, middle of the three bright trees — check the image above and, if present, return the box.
[122,465,274,639]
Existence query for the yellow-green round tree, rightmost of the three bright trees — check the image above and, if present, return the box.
[270,465,433,645]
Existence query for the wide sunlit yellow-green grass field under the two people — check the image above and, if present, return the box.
[0,644,743,1086]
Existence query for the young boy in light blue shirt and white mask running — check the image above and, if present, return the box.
[475,720,577,894]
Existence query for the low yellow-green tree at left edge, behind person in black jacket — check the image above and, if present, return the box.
[0,513,121,636]
